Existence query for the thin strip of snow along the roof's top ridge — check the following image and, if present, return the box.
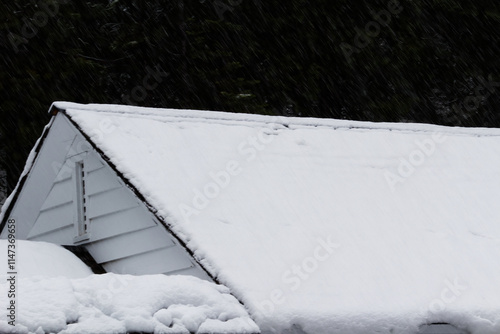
[49,101,500,136]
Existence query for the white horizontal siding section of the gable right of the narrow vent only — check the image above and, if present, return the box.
[76,145,210,280]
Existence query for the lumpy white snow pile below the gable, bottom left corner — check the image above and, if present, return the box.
[0,240,260,334]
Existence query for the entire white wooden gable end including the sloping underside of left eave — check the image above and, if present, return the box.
[7,114,210,280]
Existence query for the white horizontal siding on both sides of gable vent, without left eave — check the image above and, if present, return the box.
[20,121,210,280]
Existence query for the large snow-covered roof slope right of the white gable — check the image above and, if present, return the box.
[55,103,500,333]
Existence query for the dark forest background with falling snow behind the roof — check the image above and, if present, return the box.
[0,0,500,197]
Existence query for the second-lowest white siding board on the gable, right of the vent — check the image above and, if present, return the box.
[87,226,175,263]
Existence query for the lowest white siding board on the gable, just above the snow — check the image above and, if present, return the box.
[103,247,194,275]
